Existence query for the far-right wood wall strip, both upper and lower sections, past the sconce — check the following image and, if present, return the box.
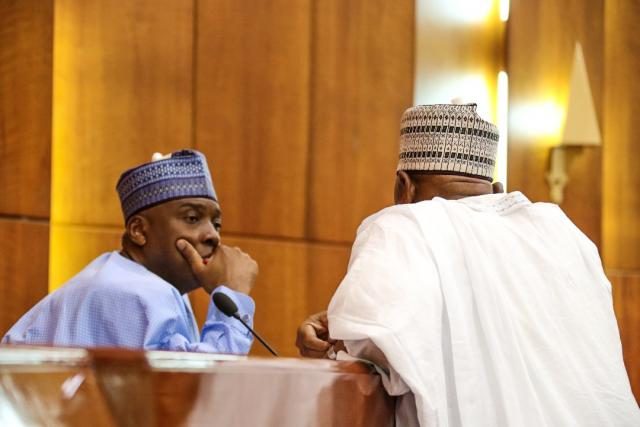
[602,0,640,402]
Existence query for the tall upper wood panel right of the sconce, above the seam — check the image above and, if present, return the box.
[603,0,640,270]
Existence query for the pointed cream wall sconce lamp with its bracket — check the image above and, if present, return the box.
[547,43,601,204]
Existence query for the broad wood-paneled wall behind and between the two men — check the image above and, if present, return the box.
[50,0,413,355]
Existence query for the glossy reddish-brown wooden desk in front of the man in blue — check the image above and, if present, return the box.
[0,346,394,427]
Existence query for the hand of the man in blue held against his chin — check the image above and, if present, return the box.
[176,239,258,295]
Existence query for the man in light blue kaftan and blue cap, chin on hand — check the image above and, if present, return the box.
[2,150,258,354]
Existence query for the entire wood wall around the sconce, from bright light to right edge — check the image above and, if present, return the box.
[508,0,640,401]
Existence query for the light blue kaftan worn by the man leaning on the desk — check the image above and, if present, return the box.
[2,252,255,354]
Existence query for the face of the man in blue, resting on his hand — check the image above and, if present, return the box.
[141,198,222,293]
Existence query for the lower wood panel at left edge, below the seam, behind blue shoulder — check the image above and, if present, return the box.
[0,219,49,337]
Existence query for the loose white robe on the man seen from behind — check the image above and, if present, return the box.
[328,192,640,427]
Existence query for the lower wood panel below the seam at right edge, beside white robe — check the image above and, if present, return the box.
[608,271,640,403]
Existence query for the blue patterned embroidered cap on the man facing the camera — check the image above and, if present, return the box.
[116,150,218,222]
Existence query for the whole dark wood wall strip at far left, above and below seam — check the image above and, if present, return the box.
[0,0,53,335]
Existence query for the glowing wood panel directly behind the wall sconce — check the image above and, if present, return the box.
[508,0,604,245]
